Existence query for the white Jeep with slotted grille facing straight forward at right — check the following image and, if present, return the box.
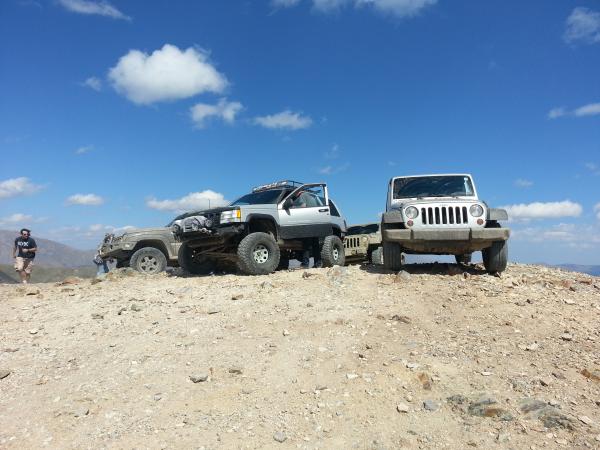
[381,174,510,273]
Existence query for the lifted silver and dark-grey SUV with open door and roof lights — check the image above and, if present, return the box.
[172,181,346,275]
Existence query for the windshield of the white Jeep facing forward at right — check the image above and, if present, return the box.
[393,175,475,199]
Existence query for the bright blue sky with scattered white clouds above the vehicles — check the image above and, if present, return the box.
[0,0,600,264]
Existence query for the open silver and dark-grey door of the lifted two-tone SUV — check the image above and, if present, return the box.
[278,184,332,239]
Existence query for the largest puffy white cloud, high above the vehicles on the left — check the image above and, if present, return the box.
[108,44,228,105]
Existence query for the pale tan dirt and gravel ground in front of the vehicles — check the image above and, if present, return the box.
[0,264,600,449]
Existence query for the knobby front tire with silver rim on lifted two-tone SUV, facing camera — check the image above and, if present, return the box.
[237,233,281,275]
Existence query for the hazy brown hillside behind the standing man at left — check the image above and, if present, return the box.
[0,230,94,268]
